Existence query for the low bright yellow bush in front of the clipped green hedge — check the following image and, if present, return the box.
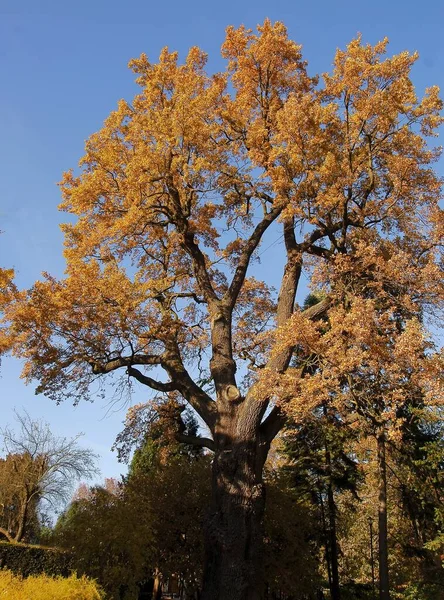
[0,570,105,600]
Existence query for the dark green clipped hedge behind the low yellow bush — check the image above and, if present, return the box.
[0,542,72,577]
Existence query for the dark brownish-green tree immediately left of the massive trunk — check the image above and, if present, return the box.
[121,399,211,600]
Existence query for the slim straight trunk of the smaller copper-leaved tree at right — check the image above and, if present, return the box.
[377,431,390,600]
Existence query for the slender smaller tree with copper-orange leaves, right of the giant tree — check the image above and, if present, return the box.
[280,254,443,600]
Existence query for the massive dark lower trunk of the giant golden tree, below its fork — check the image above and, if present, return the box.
[202,437,265,600]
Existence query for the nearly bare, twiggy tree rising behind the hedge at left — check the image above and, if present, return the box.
[0,412,97,542]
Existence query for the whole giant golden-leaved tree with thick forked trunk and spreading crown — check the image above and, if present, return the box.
[3,20,442,600]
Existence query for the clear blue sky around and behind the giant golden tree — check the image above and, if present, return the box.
[0,0,444,496]
